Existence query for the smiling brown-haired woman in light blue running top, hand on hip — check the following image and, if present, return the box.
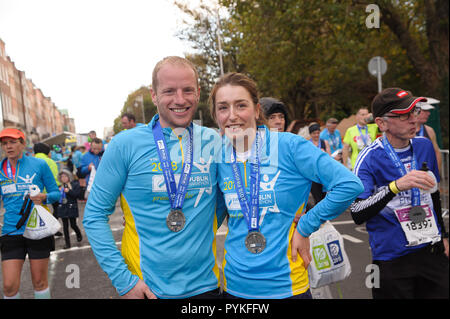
[210,73,363,299]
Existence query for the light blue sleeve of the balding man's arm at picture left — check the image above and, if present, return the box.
[83,140,139,295]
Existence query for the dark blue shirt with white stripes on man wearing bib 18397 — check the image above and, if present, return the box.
[354,137,441,260]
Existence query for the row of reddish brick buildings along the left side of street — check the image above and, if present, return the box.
[0,39,75,144]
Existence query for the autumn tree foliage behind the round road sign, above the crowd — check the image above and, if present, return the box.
[175,0,449,147]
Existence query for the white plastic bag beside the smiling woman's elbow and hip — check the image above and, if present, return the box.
[308,221,352,288]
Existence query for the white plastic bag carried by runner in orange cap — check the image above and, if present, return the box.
[23,185,61,239]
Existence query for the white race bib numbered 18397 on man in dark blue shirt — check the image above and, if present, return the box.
[394,205,441,247]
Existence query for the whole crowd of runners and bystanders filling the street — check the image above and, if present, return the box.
[0,56,449,299]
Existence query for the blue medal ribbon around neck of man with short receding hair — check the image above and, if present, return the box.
[153,121,194,210]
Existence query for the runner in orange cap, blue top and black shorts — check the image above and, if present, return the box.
[0,128,59,299]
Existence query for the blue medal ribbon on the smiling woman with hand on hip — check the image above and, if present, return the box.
[231,131,260,232]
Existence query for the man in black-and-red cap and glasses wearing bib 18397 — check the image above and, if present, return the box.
[351,88,449,299]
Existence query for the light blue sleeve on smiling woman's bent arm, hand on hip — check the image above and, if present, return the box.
[290,139,364,237]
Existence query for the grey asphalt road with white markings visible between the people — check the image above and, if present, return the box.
[0,203,448,299]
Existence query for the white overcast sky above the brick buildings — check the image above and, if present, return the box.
[0,0,197,137]
